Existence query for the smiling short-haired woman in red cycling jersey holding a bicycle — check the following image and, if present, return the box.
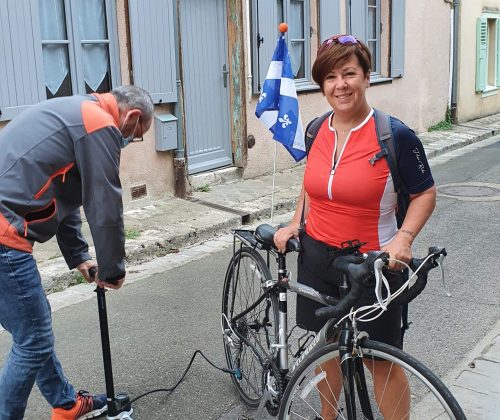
[274,35,436,419]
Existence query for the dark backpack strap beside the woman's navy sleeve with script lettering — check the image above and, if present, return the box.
[376,109,402,194]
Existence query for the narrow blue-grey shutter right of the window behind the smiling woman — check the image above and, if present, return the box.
[391,0,405,77]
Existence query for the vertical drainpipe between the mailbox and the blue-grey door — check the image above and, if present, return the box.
[173,0,188,198]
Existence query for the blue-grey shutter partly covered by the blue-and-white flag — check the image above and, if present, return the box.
[252,0,279,93]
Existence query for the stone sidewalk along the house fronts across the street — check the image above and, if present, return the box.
[34,114,500,293]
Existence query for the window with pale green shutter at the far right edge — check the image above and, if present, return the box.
[476,14,500,92]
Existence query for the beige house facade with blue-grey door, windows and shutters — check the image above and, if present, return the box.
[0,0,454,207]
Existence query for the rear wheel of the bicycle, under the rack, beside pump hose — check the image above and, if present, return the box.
[222,247,278,408]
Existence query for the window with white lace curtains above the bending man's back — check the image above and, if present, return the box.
[38,0,118,98]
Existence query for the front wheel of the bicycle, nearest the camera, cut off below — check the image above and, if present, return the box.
[279,340,466,420]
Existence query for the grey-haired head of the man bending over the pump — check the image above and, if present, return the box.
[111,85,154,143]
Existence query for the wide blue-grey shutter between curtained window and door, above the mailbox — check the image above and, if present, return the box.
[128,0,177,103]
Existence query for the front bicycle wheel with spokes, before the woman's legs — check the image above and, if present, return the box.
[279,340,466,420]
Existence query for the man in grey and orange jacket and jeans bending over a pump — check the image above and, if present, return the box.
[0,86,154,420]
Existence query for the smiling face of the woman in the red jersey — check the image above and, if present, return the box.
[323,55,370,115]
